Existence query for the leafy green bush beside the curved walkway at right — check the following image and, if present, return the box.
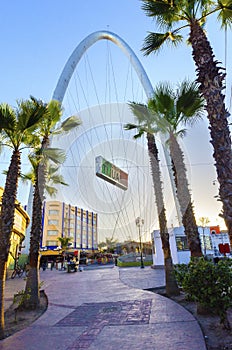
[175,258,232,329]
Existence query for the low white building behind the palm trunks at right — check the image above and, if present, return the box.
[152,226,230,267]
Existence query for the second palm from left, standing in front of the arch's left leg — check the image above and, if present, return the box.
[24,100,80,309]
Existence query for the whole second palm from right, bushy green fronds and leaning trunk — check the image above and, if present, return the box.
[148,80,204,257]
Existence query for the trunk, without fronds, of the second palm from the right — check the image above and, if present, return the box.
[169,134,202,257]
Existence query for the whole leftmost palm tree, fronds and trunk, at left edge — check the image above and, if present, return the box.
[0,100,44,339]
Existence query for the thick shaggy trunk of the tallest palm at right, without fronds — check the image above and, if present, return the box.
[189,21,232,247]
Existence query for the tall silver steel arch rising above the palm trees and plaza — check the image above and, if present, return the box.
[52,30,181,225]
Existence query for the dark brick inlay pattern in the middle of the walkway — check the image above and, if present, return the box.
[55,299,152,350]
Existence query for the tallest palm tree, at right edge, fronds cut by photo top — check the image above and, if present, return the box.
[142,0,232,246]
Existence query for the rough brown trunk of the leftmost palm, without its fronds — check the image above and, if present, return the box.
[0,150,21,339]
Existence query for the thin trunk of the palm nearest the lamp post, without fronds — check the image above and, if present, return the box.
[147,133,180,296]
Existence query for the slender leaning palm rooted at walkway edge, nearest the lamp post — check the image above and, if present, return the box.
[125,102,179,296]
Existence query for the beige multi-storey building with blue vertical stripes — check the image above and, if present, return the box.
[40,201,98,250]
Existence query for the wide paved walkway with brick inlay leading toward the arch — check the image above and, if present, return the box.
[0,267,206,350]
